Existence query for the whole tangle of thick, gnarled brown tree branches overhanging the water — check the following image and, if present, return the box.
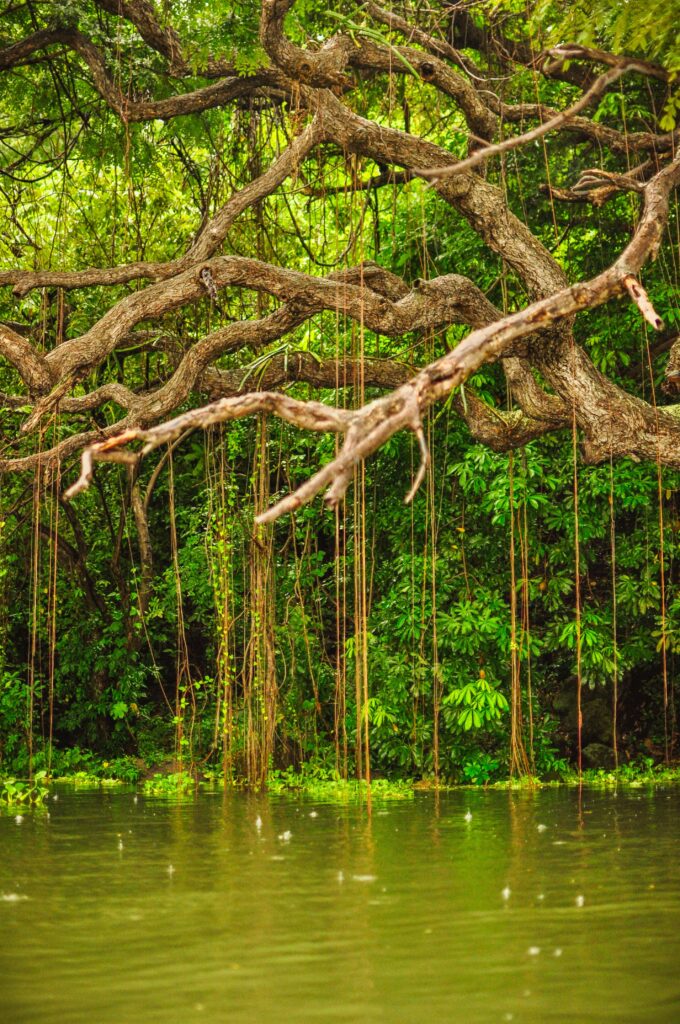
[0,0,679,517]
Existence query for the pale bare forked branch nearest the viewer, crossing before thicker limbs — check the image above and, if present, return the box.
[62,148,680,523]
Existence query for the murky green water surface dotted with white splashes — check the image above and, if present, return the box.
[0,788,680,1024]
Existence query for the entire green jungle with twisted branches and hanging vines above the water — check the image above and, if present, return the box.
[0,0,680,782]
